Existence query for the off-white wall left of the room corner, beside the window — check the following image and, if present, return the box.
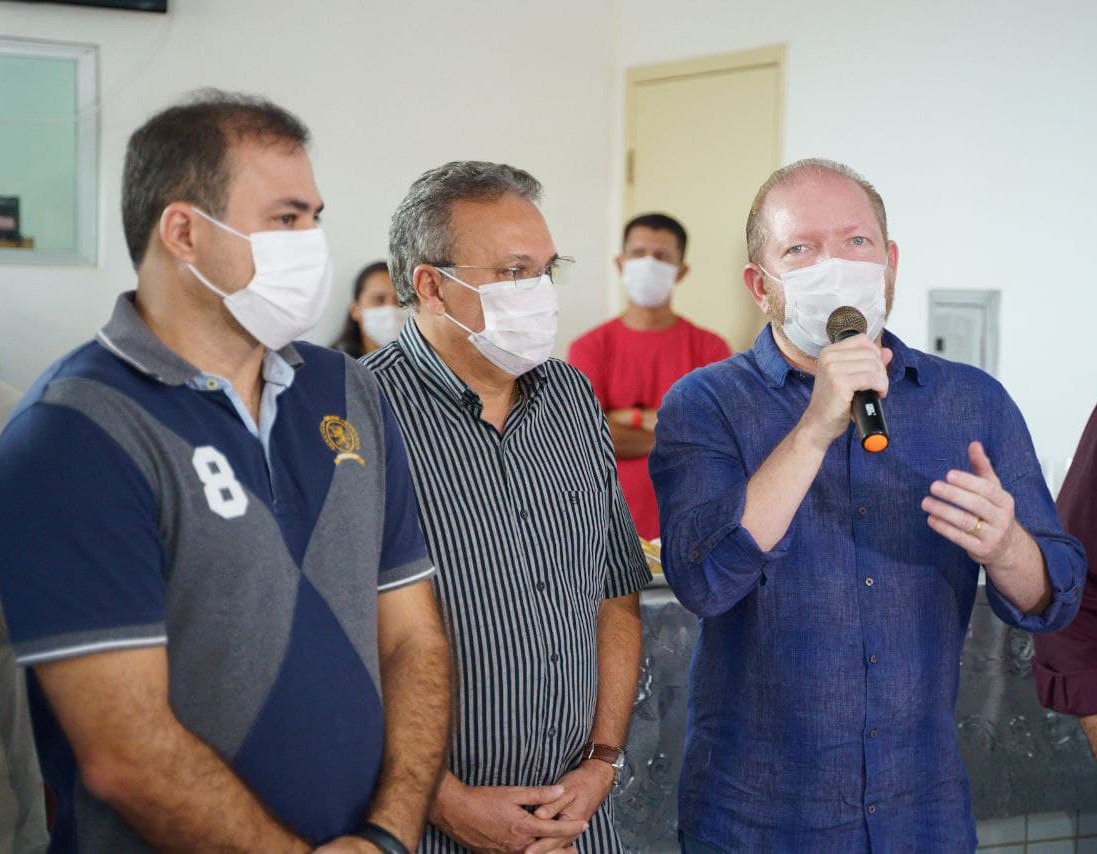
[0,0,611,387]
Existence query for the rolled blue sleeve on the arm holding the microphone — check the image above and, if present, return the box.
[648,374,791,617]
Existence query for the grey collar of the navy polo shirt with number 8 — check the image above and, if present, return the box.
[95,291,304,385]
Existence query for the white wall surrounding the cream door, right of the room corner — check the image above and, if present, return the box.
[610,0,1097,459]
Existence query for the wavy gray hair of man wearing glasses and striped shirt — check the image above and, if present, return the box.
[388,160,541,306]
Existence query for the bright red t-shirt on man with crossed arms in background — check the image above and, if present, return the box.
[567,317,732,539]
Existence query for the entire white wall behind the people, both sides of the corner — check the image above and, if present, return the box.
[0,0,1097,459]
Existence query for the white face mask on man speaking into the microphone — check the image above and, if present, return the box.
[759,258,887,359]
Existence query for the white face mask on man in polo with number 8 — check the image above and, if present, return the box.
[186,207,331,350]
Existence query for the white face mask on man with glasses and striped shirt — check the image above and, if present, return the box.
[439,268,559,377]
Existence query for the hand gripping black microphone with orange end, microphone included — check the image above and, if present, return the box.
[804,306,892,451]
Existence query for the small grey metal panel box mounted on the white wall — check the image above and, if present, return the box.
[929,290,1002,374]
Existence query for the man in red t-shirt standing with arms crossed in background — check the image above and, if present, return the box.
[567,213,732,539]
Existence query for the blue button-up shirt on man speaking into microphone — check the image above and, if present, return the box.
[651,327,1085,854]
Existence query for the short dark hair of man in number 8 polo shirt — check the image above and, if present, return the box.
[122,89,309,268]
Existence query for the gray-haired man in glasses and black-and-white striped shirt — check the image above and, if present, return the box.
[364,161,651,852]
